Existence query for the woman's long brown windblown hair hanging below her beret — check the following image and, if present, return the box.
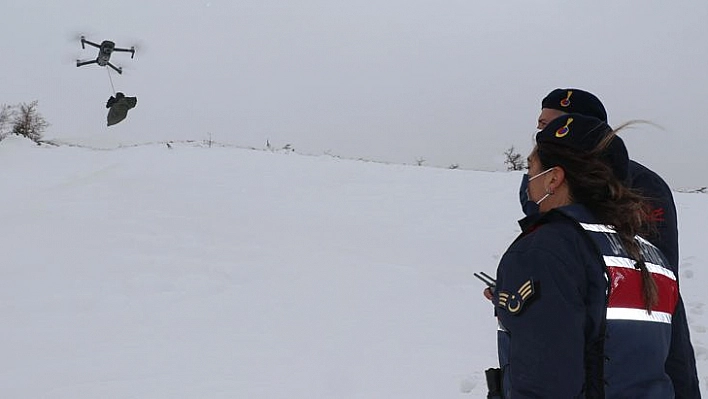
[536,124,659,312]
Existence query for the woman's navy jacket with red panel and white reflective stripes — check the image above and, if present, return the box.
[495,205,700,399]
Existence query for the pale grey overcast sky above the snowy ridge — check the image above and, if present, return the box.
[0,0,708,188]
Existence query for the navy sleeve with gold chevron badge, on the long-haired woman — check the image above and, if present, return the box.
[495,246,586,399]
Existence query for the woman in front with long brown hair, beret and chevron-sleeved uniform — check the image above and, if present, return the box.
[492,113,700,399]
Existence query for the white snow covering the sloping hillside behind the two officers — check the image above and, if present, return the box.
[0,137,708,399]
